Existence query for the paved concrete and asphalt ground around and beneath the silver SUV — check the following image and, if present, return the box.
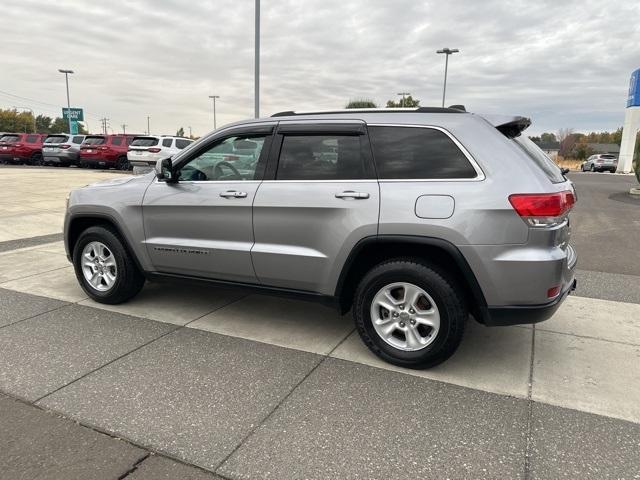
[0,169,640,479]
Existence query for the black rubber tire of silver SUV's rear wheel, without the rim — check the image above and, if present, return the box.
[353,259,469,369]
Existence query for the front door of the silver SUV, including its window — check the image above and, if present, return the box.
[143,126,273,283]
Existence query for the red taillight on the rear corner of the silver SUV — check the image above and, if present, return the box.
[509,190,576,227]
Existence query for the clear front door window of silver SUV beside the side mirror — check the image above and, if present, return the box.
[179,135,267,181]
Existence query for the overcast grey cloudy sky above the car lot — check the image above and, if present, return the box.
[0,0,640,135]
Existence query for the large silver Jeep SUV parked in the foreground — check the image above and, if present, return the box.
[64,108,576,368]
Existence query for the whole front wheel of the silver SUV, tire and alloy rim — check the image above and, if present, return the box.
[73,226,145,304]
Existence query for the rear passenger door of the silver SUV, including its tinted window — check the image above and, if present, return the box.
[251,121,380,295]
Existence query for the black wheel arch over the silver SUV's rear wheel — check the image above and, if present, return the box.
[335,235,488,323]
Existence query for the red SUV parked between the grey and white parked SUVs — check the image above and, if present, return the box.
[79,134,135,170]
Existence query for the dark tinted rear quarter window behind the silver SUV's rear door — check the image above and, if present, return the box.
[369,127,477,179]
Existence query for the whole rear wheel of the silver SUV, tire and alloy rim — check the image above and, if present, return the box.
[353,259,468,368]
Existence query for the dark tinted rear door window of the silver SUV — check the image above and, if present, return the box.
[276,135,366,180]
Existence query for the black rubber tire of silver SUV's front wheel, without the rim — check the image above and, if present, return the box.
[73,226,145,305]
